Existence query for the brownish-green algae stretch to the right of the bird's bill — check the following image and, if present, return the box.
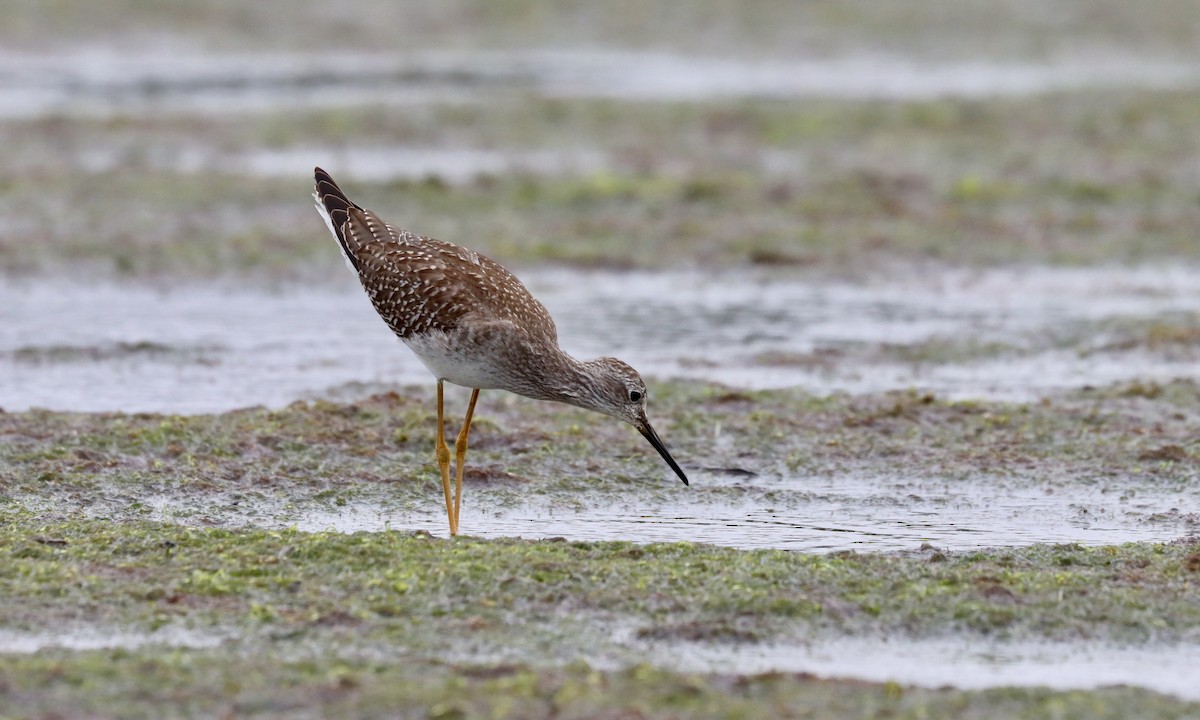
[652,380,1200,488]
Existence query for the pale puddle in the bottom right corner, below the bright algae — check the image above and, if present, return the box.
[646,638,1200,700]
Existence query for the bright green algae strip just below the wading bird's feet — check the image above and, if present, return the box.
[0,512,1200,650]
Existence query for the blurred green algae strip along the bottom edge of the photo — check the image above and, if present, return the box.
[0,650,1200,720]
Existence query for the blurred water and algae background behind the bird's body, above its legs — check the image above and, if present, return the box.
[0,0,1200,413]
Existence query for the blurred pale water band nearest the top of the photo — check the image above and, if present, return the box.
[0,48,1200,118]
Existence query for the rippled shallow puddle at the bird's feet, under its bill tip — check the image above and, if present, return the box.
[133,470,1200,552]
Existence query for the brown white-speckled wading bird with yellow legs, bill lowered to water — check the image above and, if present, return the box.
[313,168,688,534]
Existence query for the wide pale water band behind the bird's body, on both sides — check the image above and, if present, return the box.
[0,265,1200,413]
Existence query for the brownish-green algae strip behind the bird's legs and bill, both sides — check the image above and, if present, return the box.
[7,380,1200,513]
